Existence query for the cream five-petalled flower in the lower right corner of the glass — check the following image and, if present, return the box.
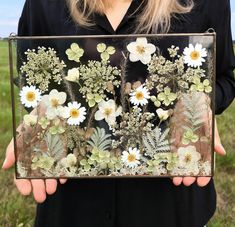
[177,146,201,169]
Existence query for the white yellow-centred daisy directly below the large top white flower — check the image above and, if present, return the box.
[130,86,150,106]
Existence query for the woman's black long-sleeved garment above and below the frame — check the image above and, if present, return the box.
[18,0,235,227]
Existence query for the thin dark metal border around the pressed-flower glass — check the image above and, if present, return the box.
[8,32,216,180]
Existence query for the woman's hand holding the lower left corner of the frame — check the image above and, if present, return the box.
[2,139,66,203]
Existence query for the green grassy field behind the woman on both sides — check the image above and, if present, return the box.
[0,41,235,227]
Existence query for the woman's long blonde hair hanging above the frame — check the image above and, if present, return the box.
[67,0,194,33]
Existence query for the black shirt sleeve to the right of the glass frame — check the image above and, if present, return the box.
[208,0,235,114]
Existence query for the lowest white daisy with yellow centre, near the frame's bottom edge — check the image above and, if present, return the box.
[122,147,141,168]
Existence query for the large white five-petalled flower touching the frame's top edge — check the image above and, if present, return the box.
[127,38,156,65]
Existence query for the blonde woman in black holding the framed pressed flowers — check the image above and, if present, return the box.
[3,0,235,227]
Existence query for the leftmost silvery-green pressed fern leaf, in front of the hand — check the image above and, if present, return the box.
[45,133,64,161]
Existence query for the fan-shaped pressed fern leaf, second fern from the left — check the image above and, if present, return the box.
[87,127,112,151]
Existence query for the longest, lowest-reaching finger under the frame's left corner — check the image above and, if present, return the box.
[31,180,46,203]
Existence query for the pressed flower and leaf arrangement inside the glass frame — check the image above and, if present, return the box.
[8,33,215,178]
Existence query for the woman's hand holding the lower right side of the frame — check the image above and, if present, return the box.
[173,120,226,187]
